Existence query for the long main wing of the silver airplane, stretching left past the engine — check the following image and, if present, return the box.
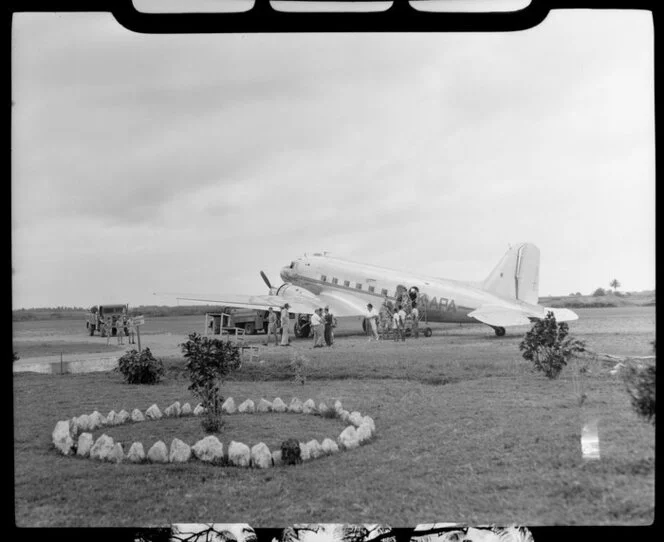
[171,288,366,317]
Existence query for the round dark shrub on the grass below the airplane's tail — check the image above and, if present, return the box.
[519,311,585,378]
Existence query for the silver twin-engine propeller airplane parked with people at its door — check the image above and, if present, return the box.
[172,243,578,337]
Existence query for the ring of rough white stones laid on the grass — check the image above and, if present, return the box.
[52,397,376,468]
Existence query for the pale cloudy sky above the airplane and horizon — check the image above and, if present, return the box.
[11,10,655,308]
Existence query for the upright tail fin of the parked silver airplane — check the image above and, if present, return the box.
[482,243,539,305]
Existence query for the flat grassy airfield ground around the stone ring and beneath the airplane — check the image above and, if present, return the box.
[13,306,655,527]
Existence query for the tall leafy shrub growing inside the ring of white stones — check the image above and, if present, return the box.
[180,333,240,433]
